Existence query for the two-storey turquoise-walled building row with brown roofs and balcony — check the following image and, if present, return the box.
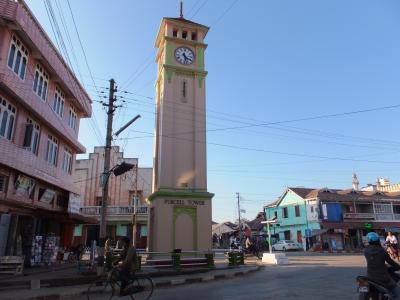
[265,188,400,250]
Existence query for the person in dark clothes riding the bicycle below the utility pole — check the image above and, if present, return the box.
[119,237,137,296]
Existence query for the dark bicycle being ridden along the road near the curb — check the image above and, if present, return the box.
[86,267,154,300]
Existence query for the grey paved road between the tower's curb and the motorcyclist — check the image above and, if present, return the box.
[90,254,365,300]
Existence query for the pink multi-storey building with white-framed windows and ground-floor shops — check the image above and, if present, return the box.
[0,0,91,260]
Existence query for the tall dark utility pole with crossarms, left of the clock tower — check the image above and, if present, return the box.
[99,79,117,248]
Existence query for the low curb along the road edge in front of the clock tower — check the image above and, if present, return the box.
[2,266,262,300]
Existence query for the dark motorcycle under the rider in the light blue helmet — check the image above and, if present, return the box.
[357,267,400,300]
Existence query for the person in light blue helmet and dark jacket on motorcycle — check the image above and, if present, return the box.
[364,232,400,300]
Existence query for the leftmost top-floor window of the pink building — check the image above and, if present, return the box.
[7,35,29,79]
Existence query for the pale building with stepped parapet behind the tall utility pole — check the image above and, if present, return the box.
[74,146,153,248]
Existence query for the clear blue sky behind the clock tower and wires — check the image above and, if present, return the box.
[27,0,400,221]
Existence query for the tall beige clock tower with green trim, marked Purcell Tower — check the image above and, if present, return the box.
[148,4,214,252]
